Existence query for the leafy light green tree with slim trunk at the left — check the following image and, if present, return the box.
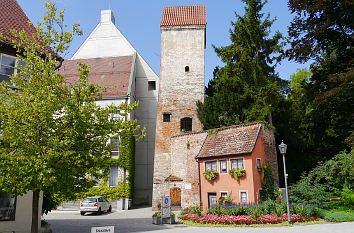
[0,2,139,233]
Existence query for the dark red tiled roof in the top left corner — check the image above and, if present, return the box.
[0,0,36,42]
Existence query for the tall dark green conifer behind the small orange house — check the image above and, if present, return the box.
[197,0,284,129]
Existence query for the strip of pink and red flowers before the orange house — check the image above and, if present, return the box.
[181,214,319,225]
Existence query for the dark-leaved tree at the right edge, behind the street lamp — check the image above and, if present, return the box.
[286,0,354,159]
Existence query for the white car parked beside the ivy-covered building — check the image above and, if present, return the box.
[80,197,112,215]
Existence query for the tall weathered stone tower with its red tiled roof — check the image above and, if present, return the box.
[152,6,206,208]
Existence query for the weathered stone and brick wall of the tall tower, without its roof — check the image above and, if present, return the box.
[152,25,205,208]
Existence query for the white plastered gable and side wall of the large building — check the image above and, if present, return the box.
[71,10,159,205]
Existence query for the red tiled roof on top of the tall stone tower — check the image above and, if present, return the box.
[160,5,206,27]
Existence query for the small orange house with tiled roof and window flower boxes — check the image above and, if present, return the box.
[196,123,278,211]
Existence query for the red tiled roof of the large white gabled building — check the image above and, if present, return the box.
[59,56,133,97]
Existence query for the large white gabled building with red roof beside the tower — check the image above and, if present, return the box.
[60,10,159,205]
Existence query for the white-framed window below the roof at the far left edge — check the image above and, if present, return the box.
[0,54,26,83]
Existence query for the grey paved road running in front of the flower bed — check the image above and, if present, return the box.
[45,208,354,233]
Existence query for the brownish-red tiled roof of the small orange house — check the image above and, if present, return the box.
[197,123,262,159]
